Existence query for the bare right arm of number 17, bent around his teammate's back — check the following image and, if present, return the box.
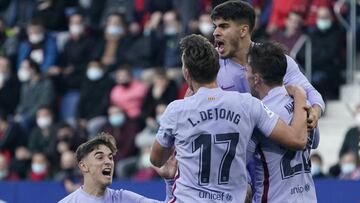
[270,87,308,150]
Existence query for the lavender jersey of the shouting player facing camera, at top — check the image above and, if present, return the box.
[217,55,325,111]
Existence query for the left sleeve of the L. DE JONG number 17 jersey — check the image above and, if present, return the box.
[156,102,177,148]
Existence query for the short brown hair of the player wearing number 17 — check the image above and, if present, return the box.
[180,34,220,84]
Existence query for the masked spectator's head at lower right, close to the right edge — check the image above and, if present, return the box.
[339,151,360,180]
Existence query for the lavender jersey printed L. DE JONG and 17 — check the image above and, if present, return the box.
[156,87,278,203]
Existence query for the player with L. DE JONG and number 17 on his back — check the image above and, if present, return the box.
[150,35,307,203]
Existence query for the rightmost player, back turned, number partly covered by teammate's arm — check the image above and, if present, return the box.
[246,42,318,203]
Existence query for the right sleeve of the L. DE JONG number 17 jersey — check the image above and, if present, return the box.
[252,97,279,137]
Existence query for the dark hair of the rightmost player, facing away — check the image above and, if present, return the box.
[248,42,287,85]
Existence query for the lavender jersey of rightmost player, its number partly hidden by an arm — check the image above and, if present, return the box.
[247,86,319,203]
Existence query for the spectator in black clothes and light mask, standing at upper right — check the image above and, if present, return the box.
[297,7,346,99]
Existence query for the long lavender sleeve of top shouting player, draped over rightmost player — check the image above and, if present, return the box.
[284,55,325,112]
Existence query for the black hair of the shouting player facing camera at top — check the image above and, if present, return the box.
[211,0,256,32]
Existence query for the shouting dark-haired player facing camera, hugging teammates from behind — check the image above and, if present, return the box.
[211,0,325,129]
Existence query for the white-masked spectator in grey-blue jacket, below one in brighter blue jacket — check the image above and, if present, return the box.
[14,59,55,131]
